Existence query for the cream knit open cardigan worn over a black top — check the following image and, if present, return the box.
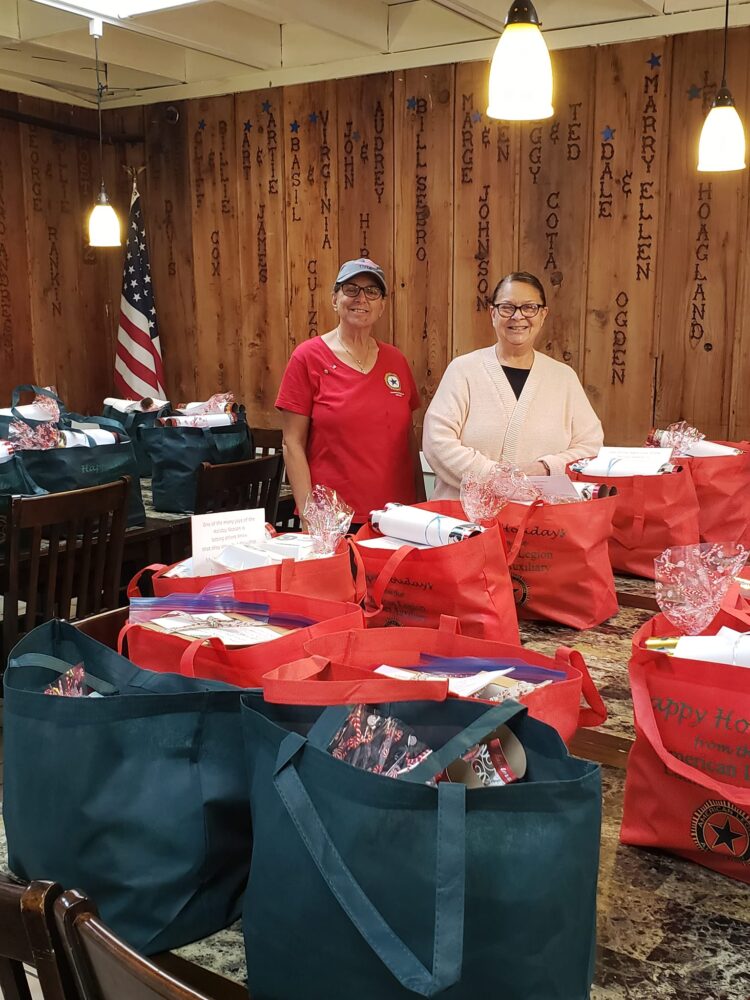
[422,346,604,500]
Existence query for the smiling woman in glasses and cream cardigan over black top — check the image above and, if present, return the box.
[422,271,604,500]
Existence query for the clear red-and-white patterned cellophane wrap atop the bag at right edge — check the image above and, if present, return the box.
[654,542,748,635]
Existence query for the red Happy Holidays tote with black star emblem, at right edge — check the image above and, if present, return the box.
[620,615,750,882]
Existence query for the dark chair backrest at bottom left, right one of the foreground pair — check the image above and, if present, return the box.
[55,889,214,1000]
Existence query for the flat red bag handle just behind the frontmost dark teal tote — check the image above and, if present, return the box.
[261,656,448,704]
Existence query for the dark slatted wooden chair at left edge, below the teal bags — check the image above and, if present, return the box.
[0,476,130,656]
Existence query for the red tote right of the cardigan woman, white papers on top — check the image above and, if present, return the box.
[568,468,700,580]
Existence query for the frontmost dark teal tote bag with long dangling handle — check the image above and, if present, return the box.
[242,694,601,1000]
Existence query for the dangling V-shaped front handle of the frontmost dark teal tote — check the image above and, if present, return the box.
[273,733,466,997]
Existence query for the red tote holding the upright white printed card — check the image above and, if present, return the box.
[128,539,365,604]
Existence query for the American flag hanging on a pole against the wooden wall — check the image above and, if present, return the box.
[115,184,166,399]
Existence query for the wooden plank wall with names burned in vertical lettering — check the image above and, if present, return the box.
[0,23,750,444]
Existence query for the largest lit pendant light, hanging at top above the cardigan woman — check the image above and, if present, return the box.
[487,0,554,121]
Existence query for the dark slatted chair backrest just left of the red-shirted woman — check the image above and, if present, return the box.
[195,455,284,524]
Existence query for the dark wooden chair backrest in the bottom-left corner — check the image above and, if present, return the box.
[0,876,78,1000]
